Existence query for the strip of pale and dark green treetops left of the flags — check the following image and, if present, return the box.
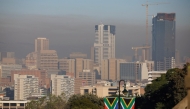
[26,94,103,109]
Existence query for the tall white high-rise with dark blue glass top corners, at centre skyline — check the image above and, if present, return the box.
[94,24,115,64]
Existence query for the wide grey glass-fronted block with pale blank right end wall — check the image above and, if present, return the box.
[120,62,148,83]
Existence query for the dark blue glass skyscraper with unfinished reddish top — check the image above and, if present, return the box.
[152,13,175,71]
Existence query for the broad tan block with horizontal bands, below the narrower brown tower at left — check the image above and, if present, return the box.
[37,50,58,70]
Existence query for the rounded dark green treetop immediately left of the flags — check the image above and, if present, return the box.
[66,94,104,109]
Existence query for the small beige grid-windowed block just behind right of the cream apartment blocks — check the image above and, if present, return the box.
[78,70,96,85]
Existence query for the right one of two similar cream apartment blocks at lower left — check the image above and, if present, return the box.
[51,74,74,100]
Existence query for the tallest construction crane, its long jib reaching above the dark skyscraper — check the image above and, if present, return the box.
[142,1,168,46]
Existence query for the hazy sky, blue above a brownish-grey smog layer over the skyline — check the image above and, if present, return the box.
[0,0,190,58]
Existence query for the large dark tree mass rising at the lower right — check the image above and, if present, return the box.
[136,63,190,109]
